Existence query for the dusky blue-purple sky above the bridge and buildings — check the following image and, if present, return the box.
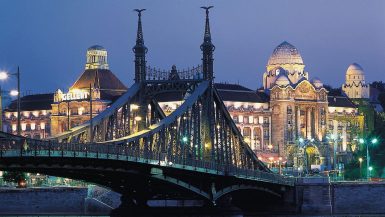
[0,0,385,93]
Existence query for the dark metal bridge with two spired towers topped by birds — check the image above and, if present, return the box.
[0,7,294,205]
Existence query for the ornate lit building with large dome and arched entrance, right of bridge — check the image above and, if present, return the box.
[259,41,364,169]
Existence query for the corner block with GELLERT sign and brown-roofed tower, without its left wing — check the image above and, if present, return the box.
[51,45,127,135]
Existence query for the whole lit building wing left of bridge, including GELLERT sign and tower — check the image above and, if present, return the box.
[3,45,127,138]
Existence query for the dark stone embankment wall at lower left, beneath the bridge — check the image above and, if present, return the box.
[0,187,87,215]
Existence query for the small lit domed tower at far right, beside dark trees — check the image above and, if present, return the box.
[342,63,369,99]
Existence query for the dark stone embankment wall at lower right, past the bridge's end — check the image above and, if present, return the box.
[296,182,385,215]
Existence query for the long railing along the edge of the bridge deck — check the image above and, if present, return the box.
[0,139,294,185]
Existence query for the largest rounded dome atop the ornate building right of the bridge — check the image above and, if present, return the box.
[267,41,304,65]
